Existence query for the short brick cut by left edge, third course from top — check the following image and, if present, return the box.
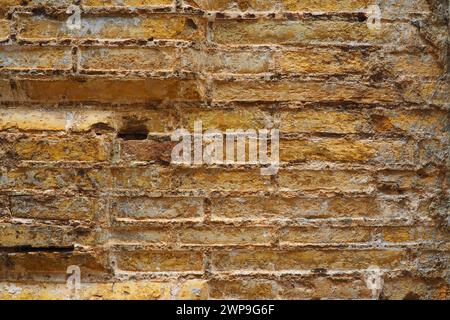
[0,46,72,70]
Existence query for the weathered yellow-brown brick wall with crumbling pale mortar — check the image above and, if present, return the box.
[0,0,450,299]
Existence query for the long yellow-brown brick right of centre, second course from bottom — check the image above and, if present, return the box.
[212,250,406,271]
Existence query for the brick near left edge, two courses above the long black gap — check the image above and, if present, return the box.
[10,195,105,220]
